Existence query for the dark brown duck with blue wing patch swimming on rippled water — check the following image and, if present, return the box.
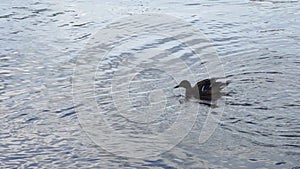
[174,78,229,101]
